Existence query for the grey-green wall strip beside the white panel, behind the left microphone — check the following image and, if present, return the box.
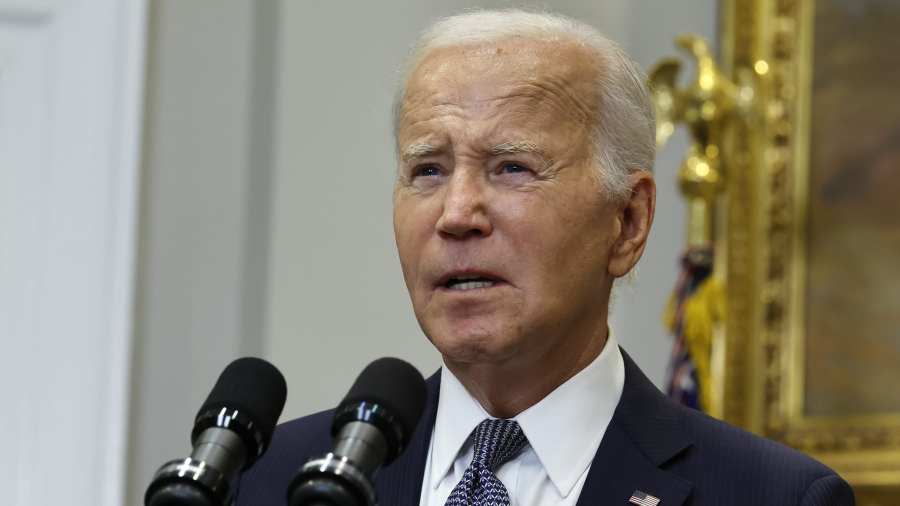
[128,0,277,504]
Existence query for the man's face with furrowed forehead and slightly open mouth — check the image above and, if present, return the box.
[394,41,621,364]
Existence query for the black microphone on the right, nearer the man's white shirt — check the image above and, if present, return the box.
[287,358,426,506]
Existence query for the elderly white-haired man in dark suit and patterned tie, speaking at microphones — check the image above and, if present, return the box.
[239,7,853,506]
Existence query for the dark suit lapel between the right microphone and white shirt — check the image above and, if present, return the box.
[375,371,441,506]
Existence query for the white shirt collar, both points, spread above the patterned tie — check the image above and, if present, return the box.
[430,331,625,497]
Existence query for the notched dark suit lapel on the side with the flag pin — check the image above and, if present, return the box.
[577,351,693,506]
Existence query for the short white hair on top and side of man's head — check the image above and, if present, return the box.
[393,9,656,198]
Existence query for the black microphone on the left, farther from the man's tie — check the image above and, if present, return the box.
[144,357,287,506]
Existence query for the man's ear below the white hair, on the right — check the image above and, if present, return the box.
[607,170,656,278]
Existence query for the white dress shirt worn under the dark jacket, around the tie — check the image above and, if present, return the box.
[419,332,625,506]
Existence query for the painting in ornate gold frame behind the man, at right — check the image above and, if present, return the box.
[714,0,900,506]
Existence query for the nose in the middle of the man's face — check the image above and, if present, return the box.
[437,170,493,239]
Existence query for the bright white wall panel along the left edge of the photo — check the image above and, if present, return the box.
[0,0,146,506]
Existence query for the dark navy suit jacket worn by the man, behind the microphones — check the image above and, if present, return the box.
[237,352,854,506]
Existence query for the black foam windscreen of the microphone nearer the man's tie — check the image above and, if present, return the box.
[338,357,426,446]
